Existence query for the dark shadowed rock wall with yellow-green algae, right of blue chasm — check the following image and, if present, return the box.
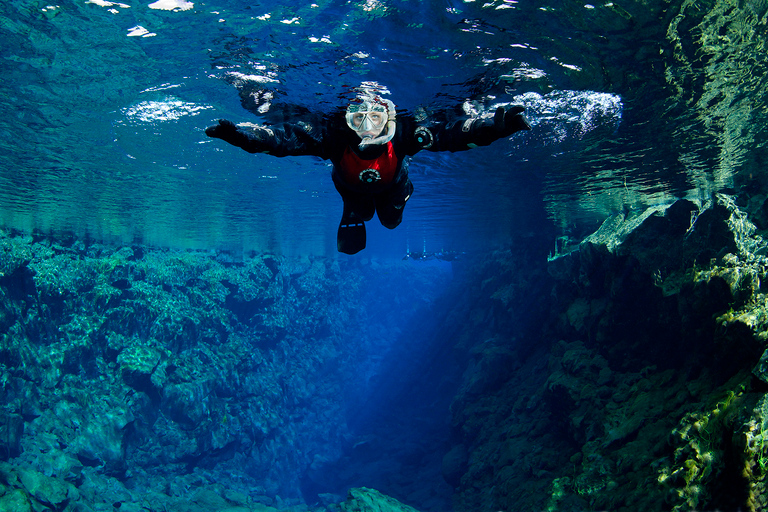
[443,195,768,511]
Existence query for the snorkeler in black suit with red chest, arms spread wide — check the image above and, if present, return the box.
[205,87,531,254]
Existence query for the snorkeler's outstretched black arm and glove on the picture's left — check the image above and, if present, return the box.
[205,119,323,156]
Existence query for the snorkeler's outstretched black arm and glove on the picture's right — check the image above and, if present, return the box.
[414,106,531,152]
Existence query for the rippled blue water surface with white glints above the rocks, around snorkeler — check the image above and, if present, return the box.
[0,0,768,255]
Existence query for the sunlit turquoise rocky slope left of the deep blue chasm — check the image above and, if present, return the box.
[0,233,452,510]
